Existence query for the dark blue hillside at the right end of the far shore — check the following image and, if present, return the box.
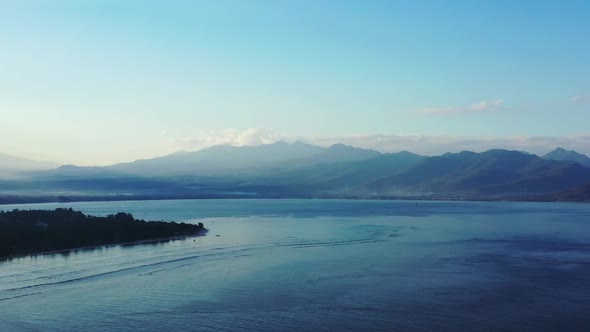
[364,150,590,196]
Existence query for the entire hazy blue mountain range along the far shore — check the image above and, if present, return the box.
[0,142,590,201]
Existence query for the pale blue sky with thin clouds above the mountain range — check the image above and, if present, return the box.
[0,0,590,165]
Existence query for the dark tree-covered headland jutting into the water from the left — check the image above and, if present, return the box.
[0,209,205,258]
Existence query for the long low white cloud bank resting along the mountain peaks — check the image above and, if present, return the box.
[171,128,590,155]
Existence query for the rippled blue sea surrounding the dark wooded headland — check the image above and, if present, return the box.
[0,200,590,331]
